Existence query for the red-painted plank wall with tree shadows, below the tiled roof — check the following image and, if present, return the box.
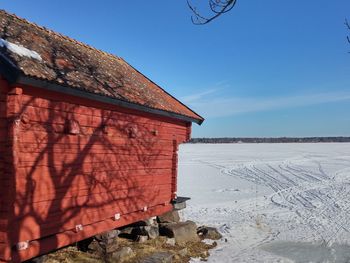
[0,79,190,261]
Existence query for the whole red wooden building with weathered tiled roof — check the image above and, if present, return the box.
[0,11,203,262]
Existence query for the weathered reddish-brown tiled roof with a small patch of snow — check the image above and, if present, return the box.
[0,10,204,124]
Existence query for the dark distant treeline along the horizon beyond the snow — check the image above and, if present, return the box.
[189,137,350,143]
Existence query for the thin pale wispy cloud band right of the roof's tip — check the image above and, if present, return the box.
[186,91,350,118]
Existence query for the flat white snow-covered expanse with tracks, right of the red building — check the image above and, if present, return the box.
[178,143,350,262]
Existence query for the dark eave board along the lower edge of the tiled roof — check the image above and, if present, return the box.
[15,75,204,125]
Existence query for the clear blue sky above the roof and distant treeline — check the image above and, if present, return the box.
[0,0,350,137]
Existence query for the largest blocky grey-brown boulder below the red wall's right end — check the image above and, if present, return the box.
[159,221,199,244]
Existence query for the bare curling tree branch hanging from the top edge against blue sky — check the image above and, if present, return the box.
[187,0,237,25]
